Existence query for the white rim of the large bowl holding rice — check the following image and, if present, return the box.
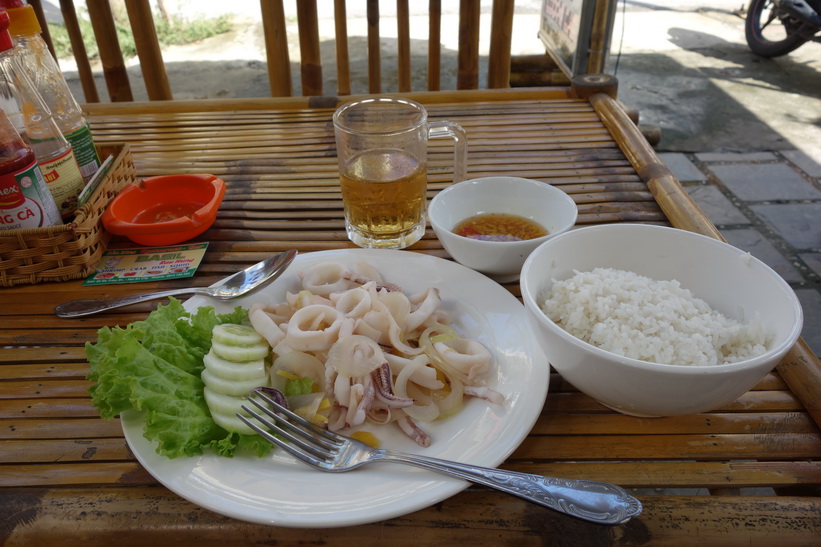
[520,223,803,376]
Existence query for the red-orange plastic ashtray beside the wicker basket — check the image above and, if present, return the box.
[103,174,225,245]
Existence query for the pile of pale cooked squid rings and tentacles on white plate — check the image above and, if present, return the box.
[243,262,504,447]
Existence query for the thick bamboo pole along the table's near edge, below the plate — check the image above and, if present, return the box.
[1,486,821,547]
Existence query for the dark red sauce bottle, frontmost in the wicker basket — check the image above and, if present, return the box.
[0,110,62,231]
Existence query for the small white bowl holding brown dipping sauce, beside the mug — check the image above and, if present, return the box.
[428,177,578,283]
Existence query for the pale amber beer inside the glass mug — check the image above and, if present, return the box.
[339,150,427,247]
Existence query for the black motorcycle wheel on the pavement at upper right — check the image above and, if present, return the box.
[744,0,807,57]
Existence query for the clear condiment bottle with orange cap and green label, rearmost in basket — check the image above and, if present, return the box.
[0,0,100,182]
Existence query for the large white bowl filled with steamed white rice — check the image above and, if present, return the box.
[520,224,803,416]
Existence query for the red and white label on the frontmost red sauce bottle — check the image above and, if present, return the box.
[0,158,60,230]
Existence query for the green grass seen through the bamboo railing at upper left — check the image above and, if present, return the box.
[49,10,233,59]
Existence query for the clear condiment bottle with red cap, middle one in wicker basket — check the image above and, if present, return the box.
[0,9,85,220]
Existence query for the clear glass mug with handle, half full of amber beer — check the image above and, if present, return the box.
[333,97,467,249]
